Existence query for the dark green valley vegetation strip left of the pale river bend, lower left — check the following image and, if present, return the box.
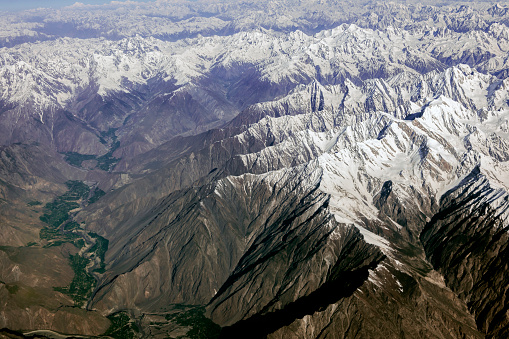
[54,254,96,307]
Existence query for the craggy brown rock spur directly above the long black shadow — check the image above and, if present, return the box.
[204,183,382,335]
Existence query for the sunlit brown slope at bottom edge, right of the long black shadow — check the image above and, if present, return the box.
[268,265,484,339]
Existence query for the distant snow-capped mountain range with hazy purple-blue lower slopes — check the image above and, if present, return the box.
[0,11,509,156]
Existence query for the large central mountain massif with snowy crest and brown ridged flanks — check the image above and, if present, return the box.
[78,62,508,337]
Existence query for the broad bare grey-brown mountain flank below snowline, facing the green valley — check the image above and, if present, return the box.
[93,165,381,324]
